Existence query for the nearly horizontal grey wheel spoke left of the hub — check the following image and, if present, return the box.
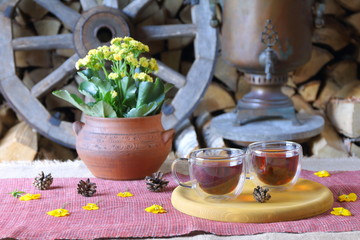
[11,34,74,50]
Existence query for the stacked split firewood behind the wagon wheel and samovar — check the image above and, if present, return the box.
[0,0,360,161]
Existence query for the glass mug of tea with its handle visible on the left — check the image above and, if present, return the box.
[171,148,246,201]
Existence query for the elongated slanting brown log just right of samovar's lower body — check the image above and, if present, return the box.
[293,46,334,84]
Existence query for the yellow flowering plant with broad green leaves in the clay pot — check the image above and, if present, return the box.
[53,37,171,118]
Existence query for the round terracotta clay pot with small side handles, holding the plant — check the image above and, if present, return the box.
[73,114,174,180]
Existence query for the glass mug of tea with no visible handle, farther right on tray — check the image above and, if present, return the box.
[246,141,303,190]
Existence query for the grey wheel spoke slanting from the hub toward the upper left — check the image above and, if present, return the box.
[34,0,81,29]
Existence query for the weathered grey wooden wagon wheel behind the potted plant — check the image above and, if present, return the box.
[0,0,217,148]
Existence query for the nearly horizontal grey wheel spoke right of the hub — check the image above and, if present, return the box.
[136,24,197,41]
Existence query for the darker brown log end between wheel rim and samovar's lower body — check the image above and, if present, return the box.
[214,56,239,92]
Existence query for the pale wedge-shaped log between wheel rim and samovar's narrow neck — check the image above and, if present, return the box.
[193,83,236,116]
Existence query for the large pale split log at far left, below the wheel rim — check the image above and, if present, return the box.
[0,122,38,162]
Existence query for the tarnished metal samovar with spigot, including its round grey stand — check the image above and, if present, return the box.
[212,0,324,142]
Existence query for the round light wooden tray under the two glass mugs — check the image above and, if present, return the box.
[171,178,334,223]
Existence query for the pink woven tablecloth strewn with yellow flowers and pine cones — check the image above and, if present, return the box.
[0,171,360,239]
